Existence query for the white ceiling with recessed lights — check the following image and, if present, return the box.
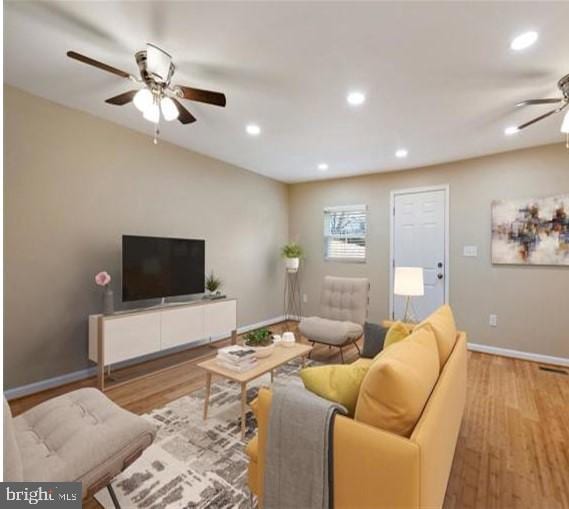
[4,1,569,182]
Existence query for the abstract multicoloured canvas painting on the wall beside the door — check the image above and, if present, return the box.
[492,193,569,266]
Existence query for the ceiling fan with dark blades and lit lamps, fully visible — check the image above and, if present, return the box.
[67,43,226,143]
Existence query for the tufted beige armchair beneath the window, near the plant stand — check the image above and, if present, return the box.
[298,276,369,362]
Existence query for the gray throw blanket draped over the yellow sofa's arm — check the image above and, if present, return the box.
[264,386,347,509]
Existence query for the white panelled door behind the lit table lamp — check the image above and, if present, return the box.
[391,188,448,321]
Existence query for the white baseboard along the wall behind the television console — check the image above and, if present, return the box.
[4,315,285,401]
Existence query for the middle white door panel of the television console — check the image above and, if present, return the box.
[162,306,206,350]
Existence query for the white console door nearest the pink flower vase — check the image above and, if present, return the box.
[103,313,160,364]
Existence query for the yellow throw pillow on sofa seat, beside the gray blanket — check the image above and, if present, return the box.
[300,364,368,417]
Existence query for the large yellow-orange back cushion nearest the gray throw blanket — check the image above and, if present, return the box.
[355,329,439,437]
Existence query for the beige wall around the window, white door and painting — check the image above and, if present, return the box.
[289,143,569,358]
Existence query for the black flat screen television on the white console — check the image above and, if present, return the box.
[122,235,205,302]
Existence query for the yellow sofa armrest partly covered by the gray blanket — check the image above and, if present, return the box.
[247,388,419,509]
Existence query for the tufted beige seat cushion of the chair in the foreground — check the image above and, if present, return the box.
[14,388,155,491]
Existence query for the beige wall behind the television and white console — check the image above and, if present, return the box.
[4,87,288,389]
